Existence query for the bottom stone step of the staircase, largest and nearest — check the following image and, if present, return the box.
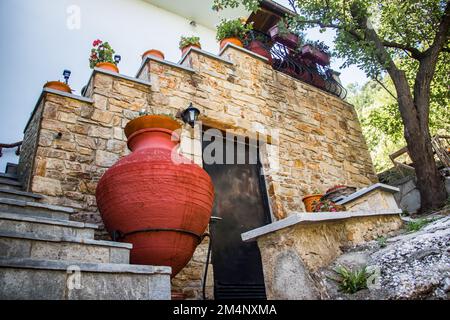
[0,259,171,300]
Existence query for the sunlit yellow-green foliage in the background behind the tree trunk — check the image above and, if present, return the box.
[347,54,450,172]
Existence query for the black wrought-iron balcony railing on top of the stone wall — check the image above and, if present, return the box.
[246,31,347,99]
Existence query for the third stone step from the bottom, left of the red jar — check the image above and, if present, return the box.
[0,212,98,239]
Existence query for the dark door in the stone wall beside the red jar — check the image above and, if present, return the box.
[203,133,270,299]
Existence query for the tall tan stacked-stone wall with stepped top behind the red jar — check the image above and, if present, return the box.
[20,46,377,298]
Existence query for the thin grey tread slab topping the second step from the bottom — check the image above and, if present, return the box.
[0,230,133,250]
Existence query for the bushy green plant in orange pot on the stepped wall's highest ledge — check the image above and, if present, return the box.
[216,19,253,50]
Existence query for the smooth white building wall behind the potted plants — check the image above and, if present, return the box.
[0,0,219,172]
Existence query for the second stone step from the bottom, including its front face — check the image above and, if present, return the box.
[0,230,133,264]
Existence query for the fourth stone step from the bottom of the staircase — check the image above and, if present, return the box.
[0,198,76,220]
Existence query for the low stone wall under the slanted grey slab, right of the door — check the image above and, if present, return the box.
[253,213,402,300]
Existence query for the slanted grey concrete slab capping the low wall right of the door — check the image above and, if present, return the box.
[241,209,402,242]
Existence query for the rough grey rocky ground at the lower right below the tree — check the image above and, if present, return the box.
[320,210,450,300]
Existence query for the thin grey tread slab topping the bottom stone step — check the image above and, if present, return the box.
[0,258,172,275]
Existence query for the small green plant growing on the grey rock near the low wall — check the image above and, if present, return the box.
[330,266,373,294]
